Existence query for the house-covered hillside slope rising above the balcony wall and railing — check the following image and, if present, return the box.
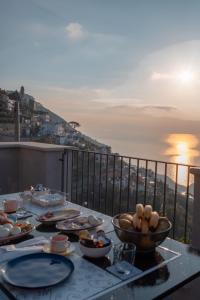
[0,87,111,153]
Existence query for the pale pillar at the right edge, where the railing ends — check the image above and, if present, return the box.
[190,168,200,250]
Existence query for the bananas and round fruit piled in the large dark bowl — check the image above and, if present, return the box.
[118,203,166,234]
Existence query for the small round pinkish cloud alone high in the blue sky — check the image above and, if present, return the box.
[65,22,88,41]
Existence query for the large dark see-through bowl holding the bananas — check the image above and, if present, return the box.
[112,213,172,253]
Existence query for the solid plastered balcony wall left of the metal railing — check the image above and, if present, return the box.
[0,142,74,194]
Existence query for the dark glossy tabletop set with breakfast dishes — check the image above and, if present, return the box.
[0,195,200,300]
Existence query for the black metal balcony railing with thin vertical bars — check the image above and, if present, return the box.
[61,150,197,242]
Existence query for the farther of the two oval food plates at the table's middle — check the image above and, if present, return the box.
[36,208,80,225]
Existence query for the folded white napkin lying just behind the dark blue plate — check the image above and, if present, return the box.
[0,237,49,263]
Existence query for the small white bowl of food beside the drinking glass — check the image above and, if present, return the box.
[79,241,112,258]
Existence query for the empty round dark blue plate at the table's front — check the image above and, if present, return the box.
[2,253,74,289]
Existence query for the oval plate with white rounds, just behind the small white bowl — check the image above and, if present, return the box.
[56,217,103,232]
